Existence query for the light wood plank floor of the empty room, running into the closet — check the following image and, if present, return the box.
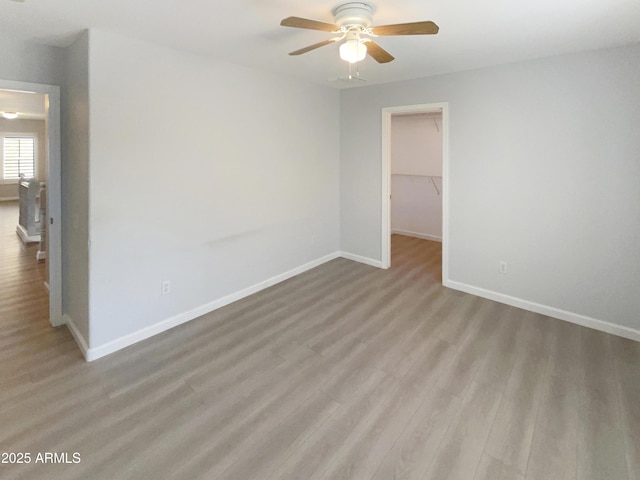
[0,229,640,480]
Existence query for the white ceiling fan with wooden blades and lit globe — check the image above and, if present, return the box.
[280,2,439,63]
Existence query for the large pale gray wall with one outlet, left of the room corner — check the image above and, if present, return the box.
[89,30,340,348]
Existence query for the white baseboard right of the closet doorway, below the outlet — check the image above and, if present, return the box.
[443,280,640,342]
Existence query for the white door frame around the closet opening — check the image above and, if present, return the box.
[380,102,449,283]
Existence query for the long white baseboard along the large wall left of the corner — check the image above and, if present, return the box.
[82,252,340,362]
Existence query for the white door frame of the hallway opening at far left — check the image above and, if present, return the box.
[0,79,64,327]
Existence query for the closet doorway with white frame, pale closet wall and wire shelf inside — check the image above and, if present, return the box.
[381,103,449,282]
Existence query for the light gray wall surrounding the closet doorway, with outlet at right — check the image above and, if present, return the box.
[341,45,640,329]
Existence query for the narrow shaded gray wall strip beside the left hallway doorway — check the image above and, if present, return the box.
[61,32,89,344]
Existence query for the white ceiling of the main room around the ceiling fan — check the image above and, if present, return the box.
[0,0,640,88]
